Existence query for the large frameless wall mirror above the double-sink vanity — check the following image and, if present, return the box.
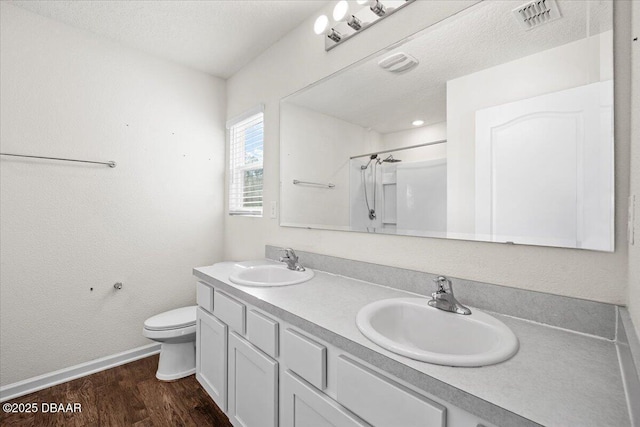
[280,0,614,251]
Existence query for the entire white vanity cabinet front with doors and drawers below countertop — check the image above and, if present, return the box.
[196,283,492,427]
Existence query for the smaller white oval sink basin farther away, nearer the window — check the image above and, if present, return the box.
[229,265,313,286]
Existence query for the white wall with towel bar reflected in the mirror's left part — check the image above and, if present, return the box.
[280,103,380,227]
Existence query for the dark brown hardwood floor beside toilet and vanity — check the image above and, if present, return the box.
[0,356,231,427]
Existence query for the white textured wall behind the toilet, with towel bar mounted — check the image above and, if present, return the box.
[0,2,226,385]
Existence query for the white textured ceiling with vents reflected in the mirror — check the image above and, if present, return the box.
[287,0,613,134]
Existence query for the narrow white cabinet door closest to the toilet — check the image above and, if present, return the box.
[196,308,227,412]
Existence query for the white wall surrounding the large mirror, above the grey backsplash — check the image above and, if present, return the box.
[225,1,631,303]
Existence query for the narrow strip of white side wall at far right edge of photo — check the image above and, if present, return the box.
[627,2,640,338]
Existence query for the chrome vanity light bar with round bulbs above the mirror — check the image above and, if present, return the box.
[313,0,416,51]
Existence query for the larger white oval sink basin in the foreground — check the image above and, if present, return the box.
[356,298,518,366]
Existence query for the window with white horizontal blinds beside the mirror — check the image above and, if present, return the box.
[227,106,264,216]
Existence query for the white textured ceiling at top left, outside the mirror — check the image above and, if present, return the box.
[9,0,327,78]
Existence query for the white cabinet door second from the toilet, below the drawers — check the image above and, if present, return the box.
[227,332,278,427]
